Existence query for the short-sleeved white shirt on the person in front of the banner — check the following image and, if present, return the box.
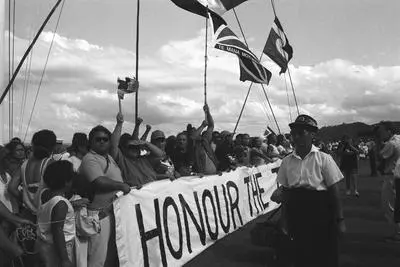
[277,145,343,191]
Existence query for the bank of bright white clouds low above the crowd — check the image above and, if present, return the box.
[0,30,400,144]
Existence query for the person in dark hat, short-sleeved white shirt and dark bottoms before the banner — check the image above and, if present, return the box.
[277,115,346,267]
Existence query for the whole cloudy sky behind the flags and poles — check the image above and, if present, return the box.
[0,0,400,144]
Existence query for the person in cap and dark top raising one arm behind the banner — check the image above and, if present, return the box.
[111,113,164,187]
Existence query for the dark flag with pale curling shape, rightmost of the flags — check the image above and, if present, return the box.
[263,17,293,74]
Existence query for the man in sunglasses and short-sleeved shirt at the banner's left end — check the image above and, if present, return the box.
[79,125,131,266]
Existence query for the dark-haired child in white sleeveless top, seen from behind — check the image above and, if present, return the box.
[37,160,75,267]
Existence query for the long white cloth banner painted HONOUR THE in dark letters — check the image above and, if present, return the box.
[114,161,280,267]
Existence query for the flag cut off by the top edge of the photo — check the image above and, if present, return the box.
[171,0,247,17]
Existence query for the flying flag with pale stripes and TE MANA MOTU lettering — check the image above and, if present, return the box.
[209,12,272,84]
